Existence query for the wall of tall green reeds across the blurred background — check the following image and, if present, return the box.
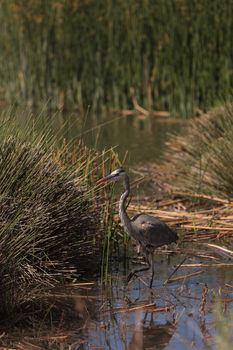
[0,0,233,115]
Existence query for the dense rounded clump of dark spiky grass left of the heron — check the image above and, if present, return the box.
[0,138,100,318]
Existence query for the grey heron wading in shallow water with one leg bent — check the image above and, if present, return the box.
[100,168,178,288]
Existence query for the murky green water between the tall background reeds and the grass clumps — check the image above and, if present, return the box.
[7,107,182,165]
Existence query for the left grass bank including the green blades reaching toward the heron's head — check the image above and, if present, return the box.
[0,114,118,323]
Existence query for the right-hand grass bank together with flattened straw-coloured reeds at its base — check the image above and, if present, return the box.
[129,102,233,241]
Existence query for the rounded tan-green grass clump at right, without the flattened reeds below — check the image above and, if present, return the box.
[162,102,233,198]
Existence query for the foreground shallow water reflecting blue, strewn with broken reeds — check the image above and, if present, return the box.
[5,254,233,350]
